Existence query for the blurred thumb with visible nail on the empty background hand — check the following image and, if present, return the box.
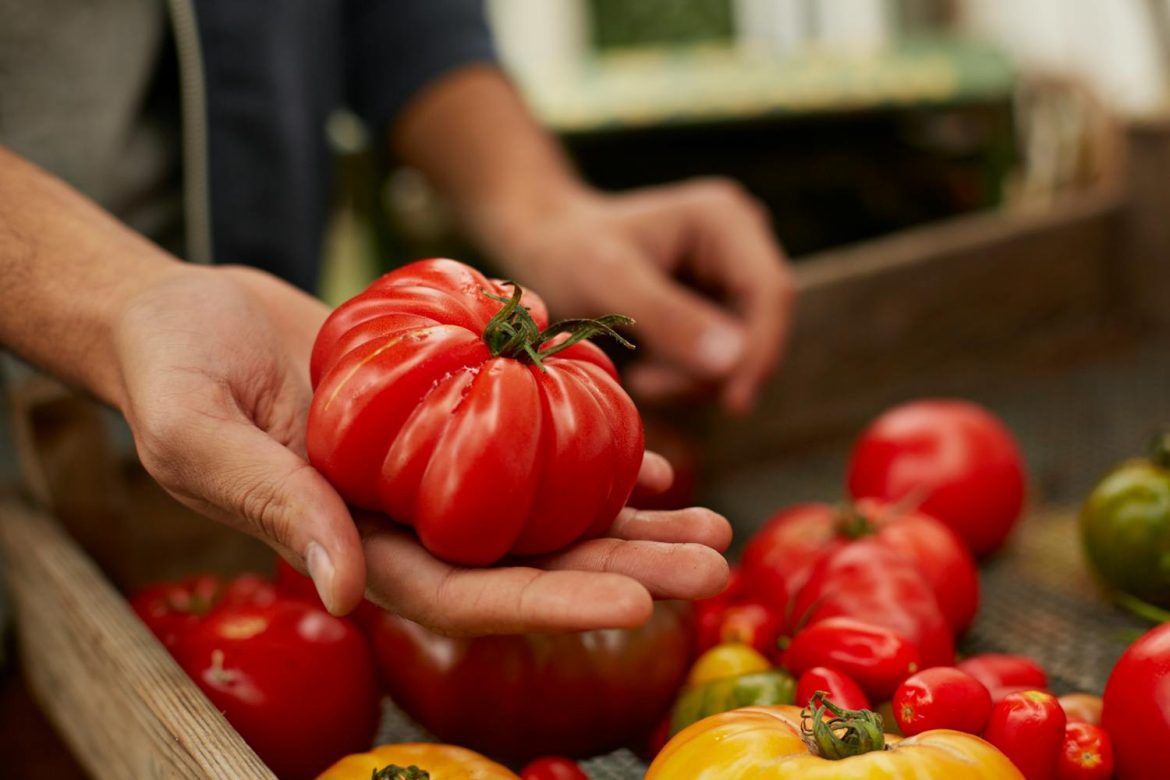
[589,240,745,379]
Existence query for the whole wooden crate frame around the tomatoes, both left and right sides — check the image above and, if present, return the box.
[0,122,1170,780]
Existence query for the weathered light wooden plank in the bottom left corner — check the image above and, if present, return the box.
[0,499,274,780]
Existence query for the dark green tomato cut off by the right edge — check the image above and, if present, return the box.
[1080,437,1170,607]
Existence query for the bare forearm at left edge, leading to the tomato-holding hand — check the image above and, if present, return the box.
[0,147,178,406]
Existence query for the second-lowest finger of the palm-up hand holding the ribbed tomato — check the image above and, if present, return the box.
[538,538,728,600]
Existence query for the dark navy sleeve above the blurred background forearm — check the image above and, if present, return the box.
[344,0,496,130]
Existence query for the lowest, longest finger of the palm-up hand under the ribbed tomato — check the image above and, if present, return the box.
[365,520,653,634]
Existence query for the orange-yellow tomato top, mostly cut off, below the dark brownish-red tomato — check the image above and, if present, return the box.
[317,743,517,780]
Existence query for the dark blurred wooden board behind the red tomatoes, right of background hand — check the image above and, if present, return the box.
[701,192,1127,476]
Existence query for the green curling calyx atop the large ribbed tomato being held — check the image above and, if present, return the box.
[483,282,634,371]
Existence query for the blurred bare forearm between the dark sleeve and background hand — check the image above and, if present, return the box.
[391,65,593,260]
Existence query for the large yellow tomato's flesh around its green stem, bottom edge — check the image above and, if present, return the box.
[646,706,1024,780]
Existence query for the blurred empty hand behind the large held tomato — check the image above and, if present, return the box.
[495,179,793,412]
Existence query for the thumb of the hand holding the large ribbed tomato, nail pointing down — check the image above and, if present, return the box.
[144,416,365,614]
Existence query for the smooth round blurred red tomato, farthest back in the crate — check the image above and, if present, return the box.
[848,399,1025,555]
